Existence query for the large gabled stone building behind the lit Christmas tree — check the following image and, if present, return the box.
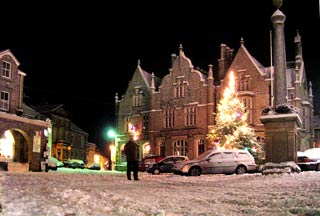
[115,33,313,169]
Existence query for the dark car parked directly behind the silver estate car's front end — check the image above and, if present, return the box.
[147,155,189,175]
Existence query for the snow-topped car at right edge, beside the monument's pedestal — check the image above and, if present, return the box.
[297,148,320,171]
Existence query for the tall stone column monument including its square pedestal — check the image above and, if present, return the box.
[260,0,301,163]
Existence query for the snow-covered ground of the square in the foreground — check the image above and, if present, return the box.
[0,169,320,216]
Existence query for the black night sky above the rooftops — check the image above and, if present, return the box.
[0,0,320,148]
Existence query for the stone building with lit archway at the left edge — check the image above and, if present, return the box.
[0,50,51,171]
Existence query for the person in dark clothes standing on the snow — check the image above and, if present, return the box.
[124,134,139,181]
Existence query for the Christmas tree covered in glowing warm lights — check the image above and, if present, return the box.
[207,71,262,163]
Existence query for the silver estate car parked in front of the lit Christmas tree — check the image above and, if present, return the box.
[173,149,257,176]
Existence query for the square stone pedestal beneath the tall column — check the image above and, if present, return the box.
[260,113,301,163]
